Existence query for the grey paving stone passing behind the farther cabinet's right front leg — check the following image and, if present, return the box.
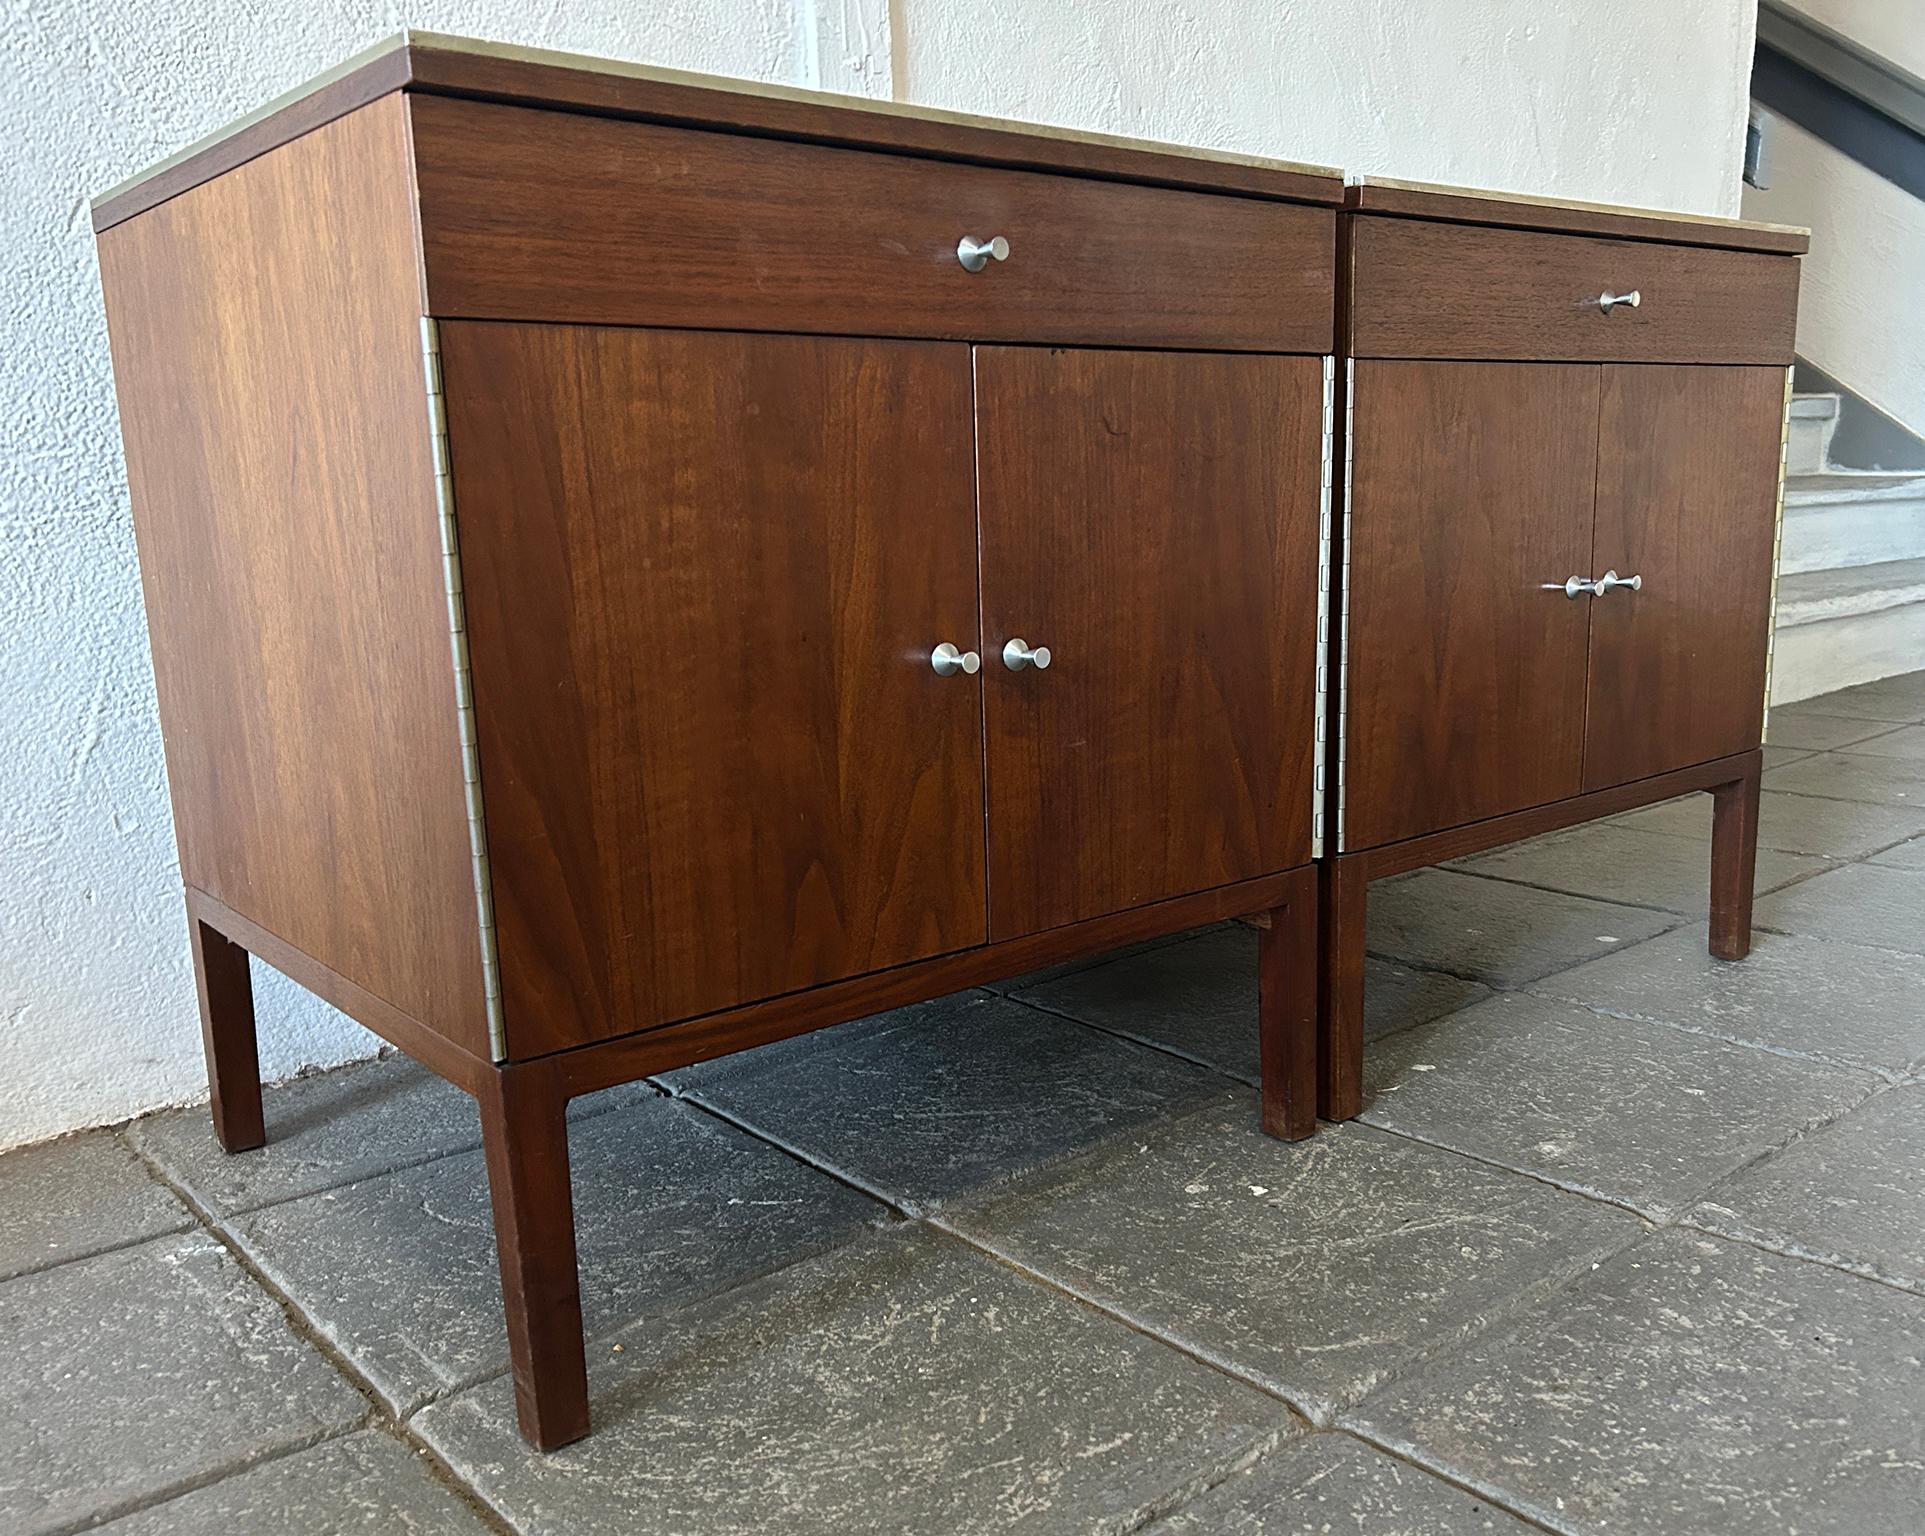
[1450,822,1831,916]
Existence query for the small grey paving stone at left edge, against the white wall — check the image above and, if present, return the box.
[0,1130,194,1280]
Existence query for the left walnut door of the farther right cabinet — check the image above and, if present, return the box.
[1342,362,1598,849]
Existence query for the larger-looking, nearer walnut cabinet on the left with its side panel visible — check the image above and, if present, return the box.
[96,40,1342,1446]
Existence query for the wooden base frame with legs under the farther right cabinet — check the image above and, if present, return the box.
[1317,749,1763,1120]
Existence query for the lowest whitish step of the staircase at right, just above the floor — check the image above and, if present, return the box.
[1771,558,1925,704]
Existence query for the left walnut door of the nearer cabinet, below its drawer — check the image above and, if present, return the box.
[441,321,986,1057]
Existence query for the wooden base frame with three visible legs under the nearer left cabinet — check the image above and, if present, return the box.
[187,864,1319,1451]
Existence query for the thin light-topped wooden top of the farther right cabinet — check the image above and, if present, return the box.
[1344,177,1811,256]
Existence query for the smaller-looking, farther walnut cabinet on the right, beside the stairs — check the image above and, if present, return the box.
[1321,185,1804,1116]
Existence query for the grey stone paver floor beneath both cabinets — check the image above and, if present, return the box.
[0,674,1925,1536]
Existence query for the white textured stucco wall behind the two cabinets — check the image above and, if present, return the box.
[0,0,1752,1147]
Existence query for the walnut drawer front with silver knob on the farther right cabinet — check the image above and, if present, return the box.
[1349,218,1798,364]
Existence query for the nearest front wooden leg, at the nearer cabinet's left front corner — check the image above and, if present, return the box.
[477,1066,589,1451]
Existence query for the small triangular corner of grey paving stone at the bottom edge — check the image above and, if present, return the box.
[1143,1434,1536,1536]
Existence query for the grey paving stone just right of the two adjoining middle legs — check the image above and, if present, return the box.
[1363,993,1877,1218]
